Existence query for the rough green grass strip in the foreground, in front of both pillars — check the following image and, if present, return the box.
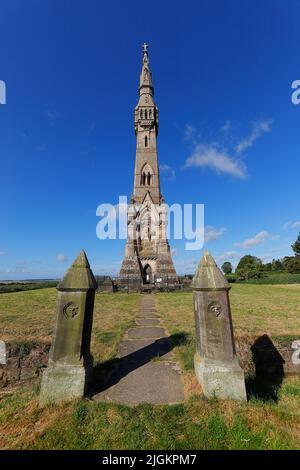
[0,378,300,450]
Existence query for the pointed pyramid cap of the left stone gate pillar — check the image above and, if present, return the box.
[57,250,98,291]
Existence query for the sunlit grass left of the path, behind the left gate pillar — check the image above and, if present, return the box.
[0,288,139,362]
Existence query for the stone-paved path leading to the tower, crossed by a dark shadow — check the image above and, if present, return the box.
[93,294,184,405]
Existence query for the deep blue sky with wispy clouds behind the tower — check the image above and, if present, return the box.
[0,0,300,279]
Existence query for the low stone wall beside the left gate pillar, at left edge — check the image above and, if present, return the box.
[0,342,50,388]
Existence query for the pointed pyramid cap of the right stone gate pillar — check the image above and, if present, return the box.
[191,250,230,290]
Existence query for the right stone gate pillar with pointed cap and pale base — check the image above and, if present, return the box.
[192,251,247,400]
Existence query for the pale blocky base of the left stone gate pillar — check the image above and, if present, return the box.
[39,362,92,406]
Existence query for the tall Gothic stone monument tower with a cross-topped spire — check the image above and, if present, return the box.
[119,44,178,286]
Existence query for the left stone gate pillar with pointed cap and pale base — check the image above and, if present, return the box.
[40,250,97,405]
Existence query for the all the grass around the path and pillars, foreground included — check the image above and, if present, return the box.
[0,284,300,450]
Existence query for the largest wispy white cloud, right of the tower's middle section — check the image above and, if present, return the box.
[185,144,247,178]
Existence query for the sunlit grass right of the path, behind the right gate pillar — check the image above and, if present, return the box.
[156,284,300,338]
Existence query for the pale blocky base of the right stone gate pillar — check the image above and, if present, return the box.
[194,353,247,401]
